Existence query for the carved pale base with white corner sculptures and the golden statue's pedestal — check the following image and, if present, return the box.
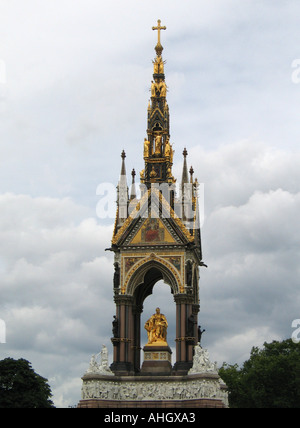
[78,343,228,409]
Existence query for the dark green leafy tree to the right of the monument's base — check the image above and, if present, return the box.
[220,339,300,408]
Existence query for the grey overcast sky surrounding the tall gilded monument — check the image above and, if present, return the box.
[0,0,300,407]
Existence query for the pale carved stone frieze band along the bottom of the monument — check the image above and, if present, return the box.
[78,373,228,408]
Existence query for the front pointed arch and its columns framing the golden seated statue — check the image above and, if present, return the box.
[112,253,199,374]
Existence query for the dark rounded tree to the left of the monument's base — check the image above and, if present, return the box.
[0,358,54,408]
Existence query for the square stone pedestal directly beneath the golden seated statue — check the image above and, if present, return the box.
[141,345,172,375]
